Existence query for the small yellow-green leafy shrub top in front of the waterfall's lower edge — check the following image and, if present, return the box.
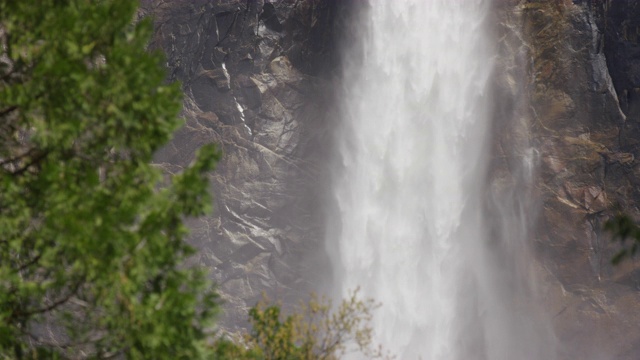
[228,291,390,360]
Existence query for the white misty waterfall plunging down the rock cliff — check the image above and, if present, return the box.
[327,0,551,360]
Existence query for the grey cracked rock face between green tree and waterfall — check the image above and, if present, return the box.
[140,0,356,329]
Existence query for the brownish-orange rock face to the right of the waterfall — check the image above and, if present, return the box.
[498,0,640,359]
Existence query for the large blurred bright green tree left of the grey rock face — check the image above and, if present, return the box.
[0,0,218,359]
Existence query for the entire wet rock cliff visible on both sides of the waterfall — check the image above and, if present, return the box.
[141,0,640,359]
